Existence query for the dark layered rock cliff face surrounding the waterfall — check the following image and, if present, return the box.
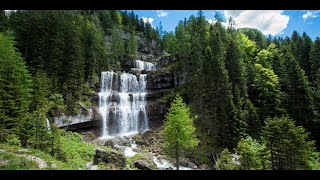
[53,31,181,134]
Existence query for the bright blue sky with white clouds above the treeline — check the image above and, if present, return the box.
[134,10,320,40]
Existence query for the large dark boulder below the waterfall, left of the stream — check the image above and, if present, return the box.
[93,148,126,167]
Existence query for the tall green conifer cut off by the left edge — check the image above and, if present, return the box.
[0,33,32,134]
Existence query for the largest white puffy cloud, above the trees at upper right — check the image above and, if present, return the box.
[223,10,290,36]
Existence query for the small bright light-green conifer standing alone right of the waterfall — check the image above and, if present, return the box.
[163,95,199,169]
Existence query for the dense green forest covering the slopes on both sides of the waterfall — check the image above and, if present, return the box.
[0,10,320,170]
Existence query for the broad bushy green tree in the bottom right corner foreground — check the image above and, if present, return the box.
[262,117,319,170]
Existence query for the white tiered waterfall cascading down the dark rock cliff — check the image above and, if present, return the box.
[99,59,155,137]
